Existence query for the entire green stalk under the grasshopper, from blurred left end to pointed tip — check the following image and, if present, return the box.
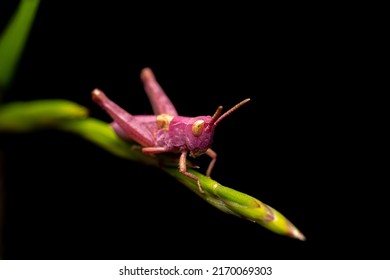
[0,100,305,240]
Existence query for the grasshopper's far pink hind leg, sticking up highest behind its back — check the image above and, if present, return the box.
[141,68,178,116]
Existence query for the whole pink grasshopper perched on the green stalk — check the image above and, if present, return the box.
[92,68,250,193]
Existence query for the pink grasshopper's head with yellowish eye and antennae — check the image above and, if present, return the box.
[186,98,250,157]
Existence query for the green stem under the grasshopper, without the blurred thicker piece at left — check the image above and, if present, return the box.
[59,118,305,240]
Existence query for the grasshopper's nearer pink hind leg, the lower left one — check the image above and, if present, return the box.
[92,89,155,147]
